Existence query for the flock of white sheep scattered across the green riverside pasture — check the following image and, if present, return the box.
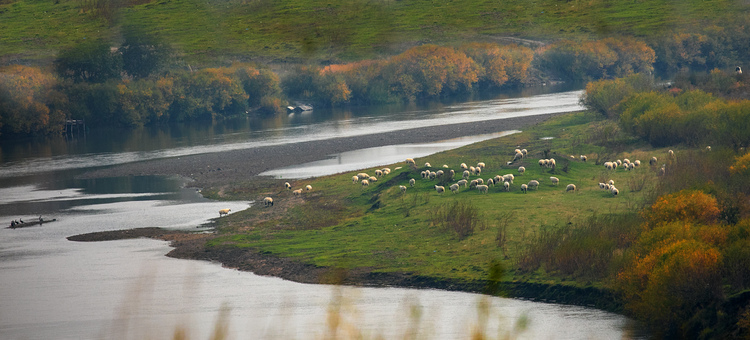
[219,146,680,217]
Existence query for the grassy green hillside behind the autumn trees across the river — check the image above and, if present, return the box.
[0,0,748,63]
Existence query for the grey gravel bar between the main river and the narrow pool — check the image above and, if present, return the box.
[81,113,560,188]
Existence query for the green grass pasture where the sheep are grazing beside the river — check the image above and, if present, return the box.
[206,113,680,286]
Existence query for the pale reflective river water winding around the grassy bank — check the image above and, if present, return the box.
[0,87,648,339]
